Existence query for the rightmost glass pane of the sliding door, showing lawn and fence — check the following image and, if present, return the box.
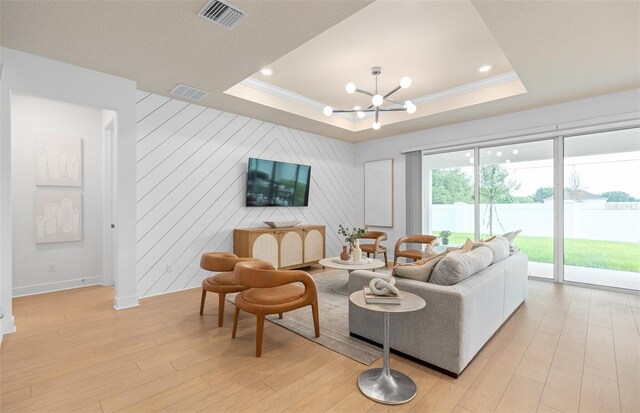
[564,129,640,290]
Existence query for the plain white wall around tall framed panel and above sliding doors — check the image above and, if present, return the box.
[356,89,640,260]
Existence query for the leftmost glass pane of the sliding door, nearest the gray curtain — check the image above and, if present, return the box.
[423,149,475,245]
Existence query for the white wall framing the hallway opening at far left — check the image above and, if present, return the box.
[0,48,138,338]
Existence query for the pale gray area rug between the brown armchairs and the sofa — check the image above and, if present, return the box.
[227,270,382,366]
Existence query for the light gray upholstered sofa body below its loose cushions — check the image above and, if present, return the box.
[349,253,528,377]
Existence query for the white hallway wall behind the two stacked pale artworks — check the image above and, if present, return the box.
[11,95,103,297]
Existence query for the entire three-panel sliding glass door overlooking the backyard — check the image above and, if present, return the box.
[423,128,640,291]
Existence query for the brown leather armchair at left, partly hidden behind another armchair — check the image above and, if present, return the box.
[200,252,255,327]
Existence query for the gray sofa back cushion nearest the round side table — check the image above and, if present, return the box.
[429,247,493,285]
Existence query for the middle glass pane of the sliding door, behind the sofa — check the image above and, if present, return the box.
[479,140,554,279]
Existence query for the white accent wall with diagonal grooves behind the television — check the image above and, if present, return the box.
[136,92,356,296]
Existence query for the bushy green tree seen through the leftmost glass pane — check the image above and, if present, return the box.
[431,168,473,204]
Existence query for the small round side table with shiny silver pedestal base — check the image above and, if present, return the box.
[349,291,426,404]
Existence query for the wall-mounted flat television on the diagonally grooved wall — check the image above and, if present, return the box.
[247,158,311,207]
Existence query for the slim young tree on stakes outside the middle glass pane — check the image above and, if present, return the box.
[480,164,520,236]
